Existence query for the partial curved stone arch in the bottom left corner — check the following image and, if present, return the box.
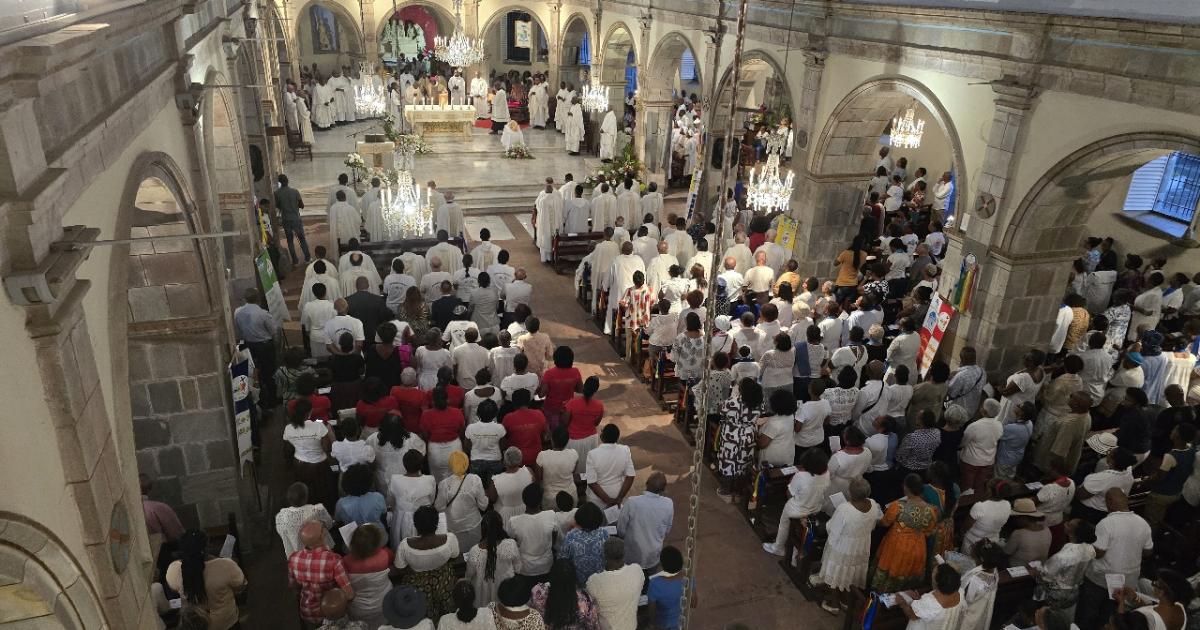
[0,511,114,630]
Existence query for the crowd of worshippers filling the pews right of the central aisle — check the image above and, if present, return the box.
[564,151,1200,630]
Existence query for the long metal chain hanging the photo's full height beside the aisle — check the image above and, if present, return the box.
[679,0,749,630]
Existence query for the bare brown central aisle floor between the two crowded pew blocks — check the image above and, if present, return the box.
[497,215,842,630]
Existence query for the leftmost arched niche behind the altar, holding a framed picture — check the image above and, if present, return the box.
[294,0,362,77]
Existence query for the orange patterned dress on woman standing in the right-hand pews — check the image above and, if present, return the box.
[871,498,937,593]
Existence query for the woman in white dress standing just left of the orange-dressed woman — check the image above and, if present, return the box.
[818,479,883,614]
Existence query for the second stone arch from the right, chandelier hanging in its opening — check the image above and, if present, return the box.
[810,76,970,208]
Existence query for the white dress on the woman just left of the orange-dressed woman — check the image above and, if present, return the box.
[821,499,883,590]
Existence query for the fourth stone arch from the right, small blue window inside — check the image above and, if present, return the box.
[636,31,702,179]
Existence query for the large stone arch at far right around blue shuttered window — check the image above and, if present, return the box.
[979,132,1200,370]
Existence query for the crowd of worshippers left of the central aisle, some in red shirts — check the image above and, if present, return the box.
[228,229,685,630]
